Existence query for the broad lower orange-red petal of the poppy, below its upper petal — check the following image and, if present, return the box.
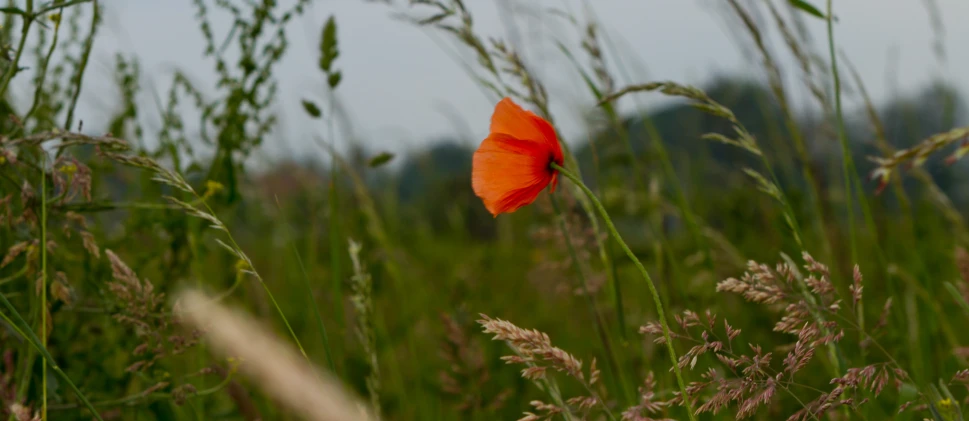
[471,133,553,216]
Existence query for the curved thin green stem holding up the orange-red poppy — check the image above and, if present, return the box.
[551,162,696,421]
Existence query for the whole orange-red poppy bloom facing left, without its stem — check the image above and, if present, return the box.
[471,98,562,217]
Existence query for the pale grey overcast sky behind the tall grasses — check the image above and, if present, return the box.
[22,0,969,162]
